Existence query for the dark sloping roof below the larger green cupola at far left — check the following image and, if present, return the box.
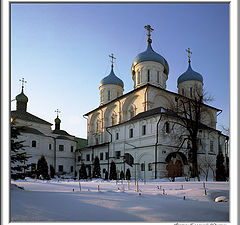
[11,110,52,126]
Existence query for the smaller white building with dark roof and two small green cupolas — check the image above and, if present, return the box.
[11,86,76,177]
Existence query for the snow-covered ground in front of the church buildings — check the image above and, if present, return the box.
[11,179,229,222]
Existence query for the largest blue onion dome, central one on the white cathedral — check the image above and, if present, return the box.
[133,43,169,75]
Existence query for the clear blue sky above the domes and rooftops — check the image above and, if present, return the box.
[11,3,229,137]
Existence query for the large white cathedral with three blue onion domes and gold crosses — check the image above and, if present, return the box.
[76,25,228,180]
